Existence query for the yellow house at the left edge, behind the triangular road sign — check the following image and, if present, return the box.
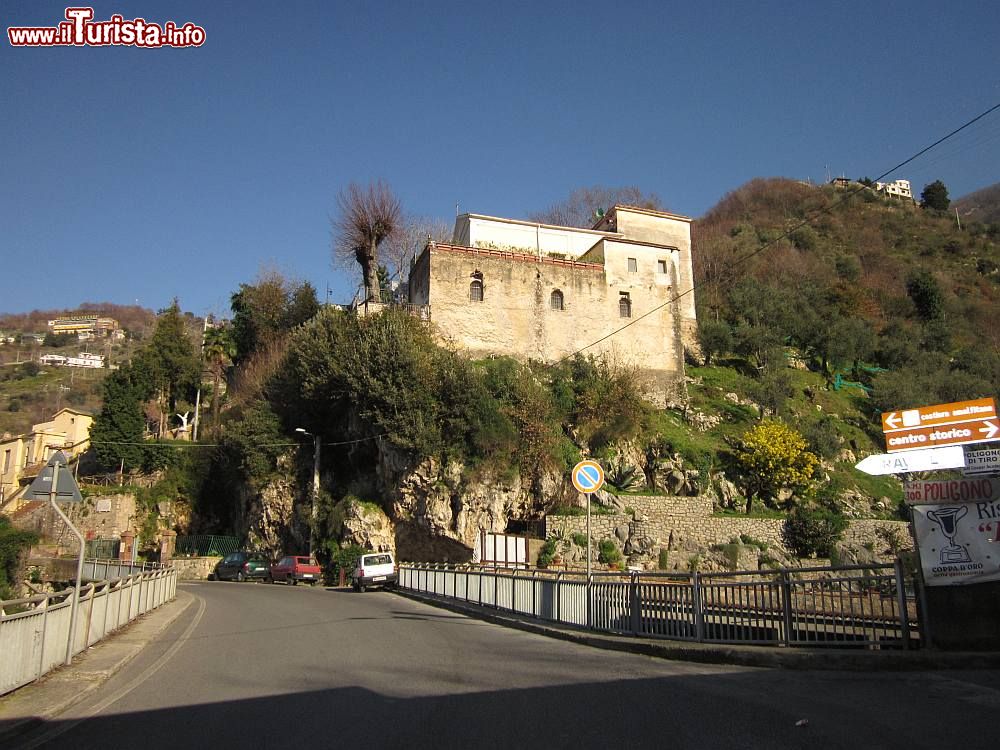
[0,409,94,511]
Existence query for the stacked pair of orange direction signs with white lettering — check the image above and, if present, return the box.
[882,398,1000,453]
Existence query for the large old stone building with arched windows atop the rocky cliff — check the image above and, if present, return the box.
[409,206,696,394]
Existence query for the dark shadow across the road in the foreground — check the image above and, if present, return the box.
[0,665,993,750]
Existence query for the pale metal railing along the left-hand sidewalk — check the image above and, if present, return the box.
[0,568,177,695]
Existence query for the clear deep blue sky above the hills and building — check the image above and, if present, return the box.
[0,0,1000,315]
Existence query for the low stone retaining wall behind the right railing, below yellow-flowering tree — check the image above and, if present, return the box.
[545,495,912,564]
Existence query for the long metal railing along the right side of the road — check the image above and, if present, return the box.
[398,561,919,649]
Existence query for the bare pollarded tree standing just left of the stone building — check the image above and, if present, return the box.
[333,180,400,300]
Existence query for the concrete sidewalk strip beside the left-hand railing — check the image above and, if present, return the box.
[0,589,194,746]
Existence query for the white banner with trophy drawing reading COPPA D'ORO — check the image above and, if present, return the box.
[907,494,1000,586]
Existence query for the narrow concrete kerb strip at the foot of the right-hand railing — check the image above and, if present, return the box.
[395,588,1000,672]
